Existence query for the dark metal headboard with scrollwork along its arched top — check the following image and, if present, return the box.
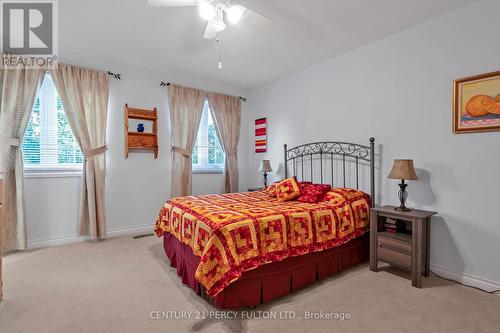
[283,138,375,207]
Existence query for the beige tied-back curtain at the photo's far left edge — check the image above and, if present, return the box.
[0,54,45,251]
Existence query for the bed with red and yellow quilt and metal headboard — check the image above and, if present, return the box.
[155,138,375,309]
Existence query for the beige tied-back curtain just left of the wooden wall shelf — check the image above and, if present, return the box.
[50,64,109,239]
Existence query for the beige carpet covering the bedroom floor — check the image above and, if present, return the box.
[0,233,500,333]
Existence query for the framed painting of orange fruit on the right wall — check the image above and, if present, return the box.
[453,72,500,133]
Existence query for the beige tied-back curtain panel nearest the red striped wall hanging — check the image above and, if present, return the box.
[208,94,241,193]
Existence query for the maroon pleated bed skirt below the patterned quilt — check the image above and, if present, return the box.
[163,233,369,309]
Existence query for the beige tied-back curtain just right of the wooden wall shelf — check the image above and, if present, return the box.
[168,84,206,198]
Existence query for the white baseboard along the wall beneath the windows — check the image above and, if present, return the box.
[28,224,154,249]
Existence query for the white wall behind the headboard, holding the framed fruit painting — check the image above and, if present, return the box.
[242,1,500,288]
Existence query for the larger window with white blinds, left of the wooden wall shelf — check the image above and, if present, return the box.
[22,73,83,171]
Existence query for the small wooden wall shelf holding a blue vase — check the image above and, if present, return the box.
[125,104,158,159]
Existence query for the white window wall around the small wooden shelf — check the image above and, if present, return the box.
[25,50,246,247]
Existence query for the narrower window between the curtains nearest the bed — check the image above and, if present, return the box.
[193,99,225,172]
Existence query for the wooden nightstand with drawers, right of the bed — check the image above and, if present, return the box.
[370,206,437,288]
